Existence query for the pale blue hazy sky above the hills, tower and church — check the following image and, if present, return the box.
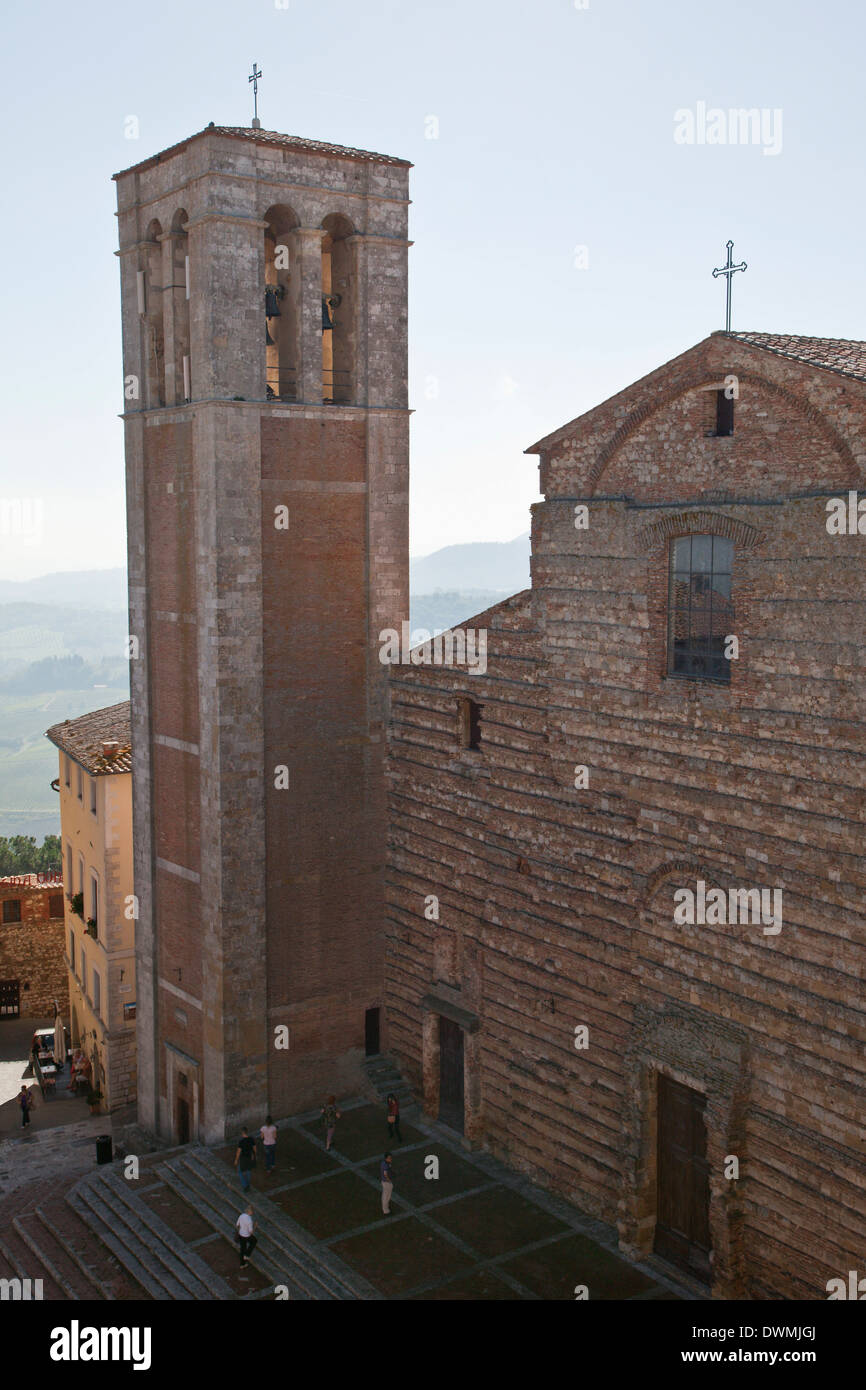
[0,0,866,578]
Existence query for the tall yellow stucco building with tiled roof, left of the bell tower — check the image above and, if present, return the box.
[46,701,136,1111]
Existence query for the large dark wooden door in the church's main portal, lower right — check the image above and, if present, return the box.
[655,1076,710,1283]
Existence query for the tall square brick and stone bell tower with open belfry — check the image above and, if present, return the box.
[115,125,409,1141]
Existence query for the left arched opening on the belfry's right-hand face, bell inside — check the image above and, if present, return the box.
[263,204,302,400]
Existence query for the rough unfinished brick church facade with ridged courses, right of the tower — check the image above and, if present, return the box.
[385,334,866,1298]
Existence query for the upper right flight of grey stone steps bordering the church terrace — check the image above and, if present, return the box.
[158,1147,379,1300]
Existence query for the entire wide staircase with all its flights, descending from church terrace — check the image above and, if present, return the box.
[0,1145,381,1301]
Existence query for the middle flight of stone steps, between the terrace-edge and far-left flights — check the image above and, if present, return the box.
[68,1170,235,1301]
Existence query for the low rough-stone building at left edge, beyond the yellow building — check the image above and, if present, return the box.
[0,874,67,1019]
